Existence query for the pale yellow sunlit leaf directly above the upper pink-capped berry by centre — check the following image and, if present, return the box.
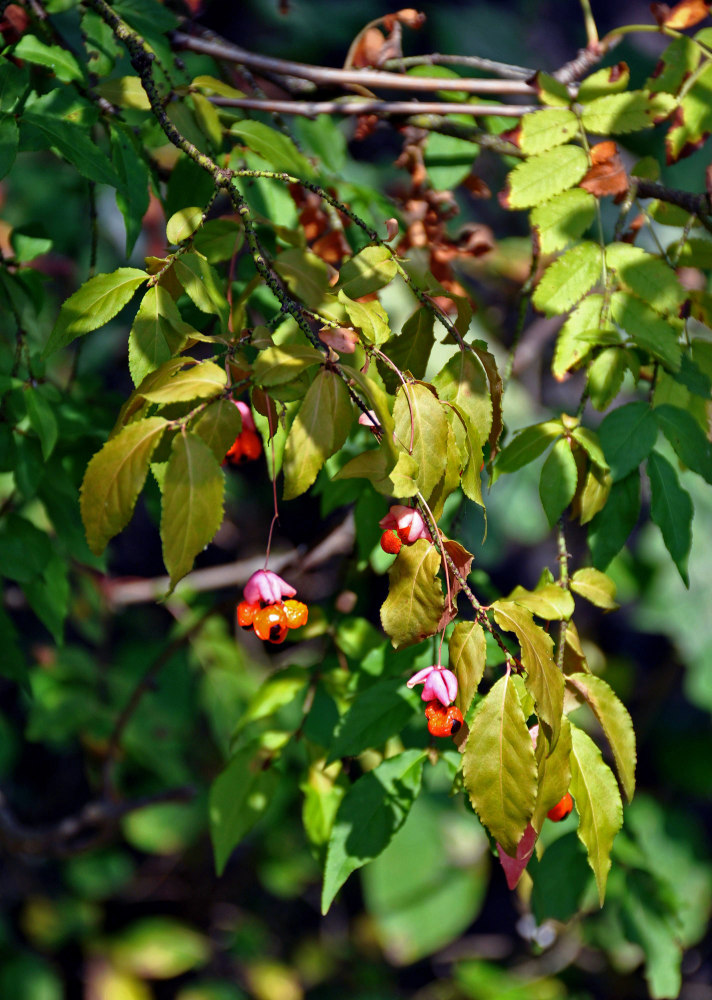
[393,382,449,500]
